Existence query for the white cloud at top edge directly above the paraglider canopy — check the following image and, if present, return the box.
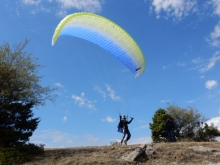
[56,0,102,12]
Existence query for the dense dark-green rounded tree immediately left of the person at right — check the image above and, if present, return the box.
[150,108,171,142]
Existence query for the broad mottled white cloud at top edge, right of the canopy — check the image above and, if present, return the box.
[152,0,196,19]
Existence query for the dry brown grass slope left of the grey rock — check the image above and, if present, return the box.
[22,145,138,165]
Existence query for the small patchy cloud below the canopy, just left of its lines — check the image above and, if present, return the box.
[72,92,96,110]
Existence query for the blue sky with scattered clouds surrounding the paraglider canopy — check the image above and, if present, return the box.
[0,0,220,147]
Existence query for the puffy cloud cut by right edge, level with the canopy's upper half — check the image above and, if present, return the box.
[208,22,220,46]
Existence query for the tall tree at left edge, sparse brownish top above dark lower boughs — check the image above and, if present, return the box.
[0,40,55,148]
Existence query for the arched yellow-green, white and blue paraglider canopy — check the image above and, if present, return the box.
[52,12,146,77]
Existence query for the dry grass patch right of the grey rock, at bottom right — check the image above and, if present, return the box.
[146,142,220,165]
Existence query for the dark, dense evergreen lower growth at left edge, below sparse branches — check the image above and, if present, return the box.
[0,103,40,148]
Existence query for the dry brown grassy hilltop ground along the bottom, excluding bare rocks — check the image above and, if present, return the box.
[22,142,220,165]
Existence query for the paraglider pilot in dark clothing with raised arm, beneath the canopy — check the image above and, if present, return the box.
[120,116,134,145]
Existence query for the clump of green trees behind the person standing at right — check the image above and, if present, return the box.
[150,104,220,142]
